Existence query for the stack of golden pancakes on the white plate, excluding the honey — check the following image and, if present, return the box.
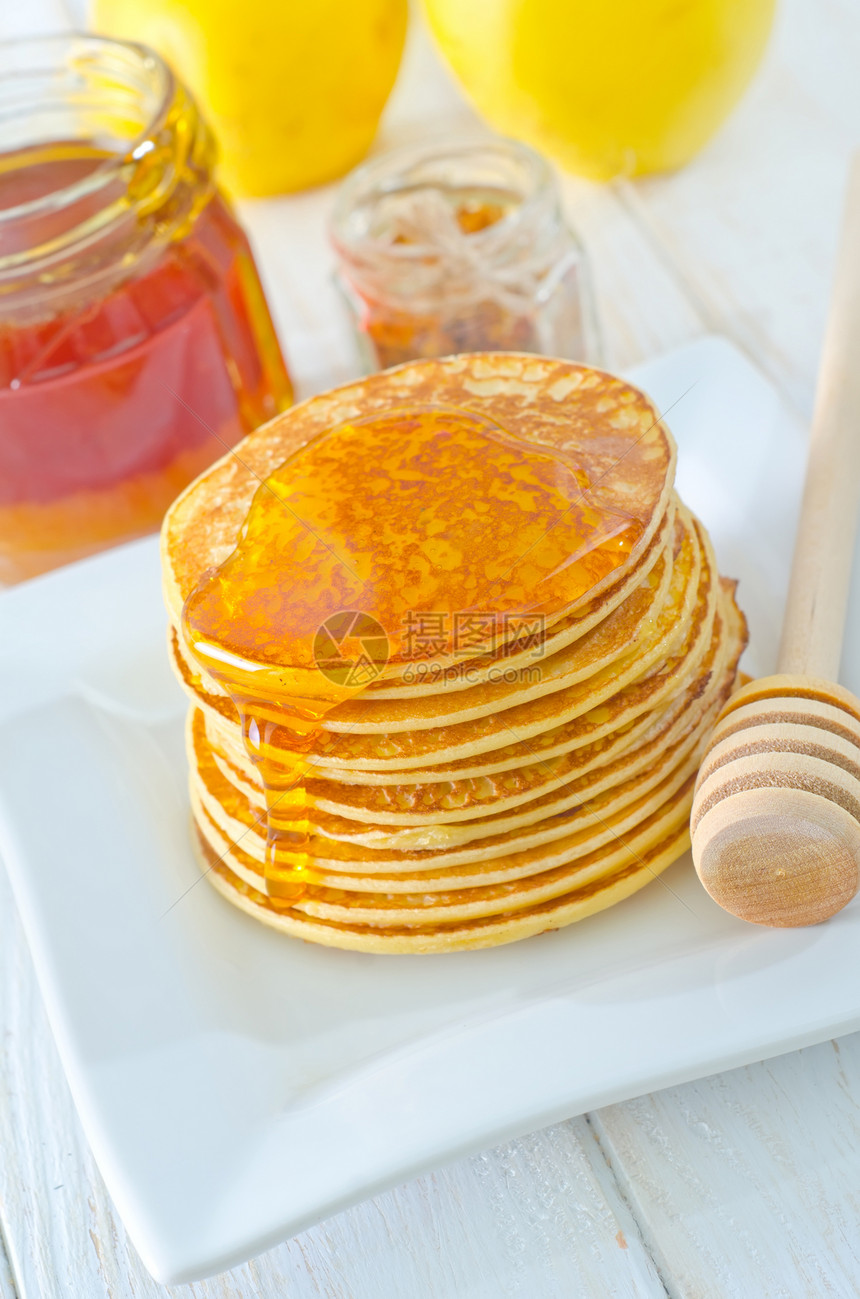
[162,353,746,952]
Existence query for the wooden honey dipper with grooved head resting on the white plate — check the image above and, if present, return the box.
[691,156,860,926]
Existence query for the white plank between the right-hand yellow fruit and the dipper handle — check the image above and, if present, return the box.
[616,0,860,418]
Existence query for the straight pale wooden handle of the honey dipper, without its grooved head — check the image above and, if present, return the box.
[778,155,860,681]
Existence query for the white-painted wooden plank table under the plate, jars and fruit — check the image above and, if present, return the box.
[0,0,860,1299]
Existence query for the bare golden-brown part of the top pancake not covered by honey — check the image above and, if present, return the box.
[162,352,674,672]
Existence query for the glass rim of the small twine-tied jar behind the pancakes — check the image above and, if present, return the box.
[329,136,556,264]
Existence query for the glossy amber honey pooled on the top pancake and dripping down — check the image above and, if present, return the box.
[182,407,643,904]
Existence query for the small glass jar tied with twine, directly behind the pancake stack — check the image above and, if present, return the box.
[331,140,600,370]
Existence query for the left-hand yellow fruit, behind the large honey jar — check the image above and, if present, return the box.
[94,0,407,195]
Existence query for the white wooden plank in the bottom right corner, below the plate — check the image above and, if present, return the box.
[592,1034,860,1299]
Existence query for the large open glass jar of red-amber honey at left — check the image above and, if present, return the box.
[0,35,292,582]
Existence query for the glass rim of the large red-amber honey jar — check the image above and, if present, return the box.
[0,31,177,228]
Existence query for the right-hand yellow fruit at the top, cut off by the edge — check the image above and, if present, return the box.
[425,0,774,181]
